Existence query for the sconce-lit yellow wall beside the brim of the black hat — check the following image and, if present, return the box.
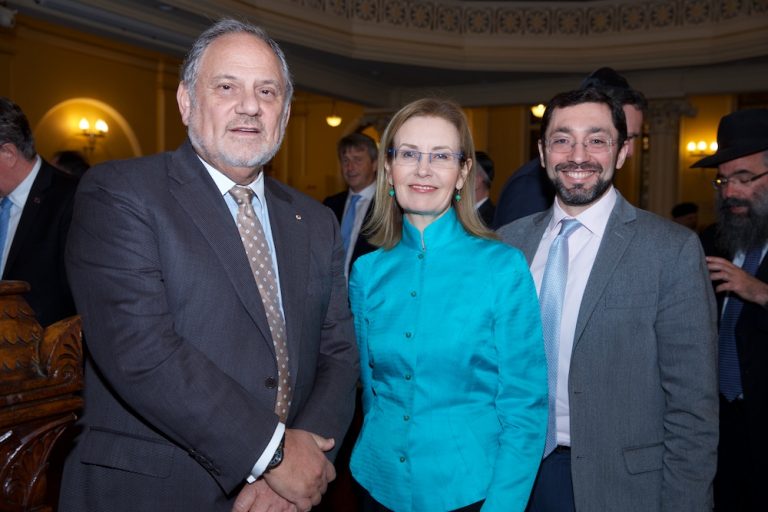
[678,95,736,229]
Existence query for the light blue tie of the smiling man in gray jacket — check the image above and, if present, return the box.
[539,219,581,457]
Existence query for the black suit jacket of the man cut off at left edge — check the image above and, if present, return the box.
[3,160,77,326]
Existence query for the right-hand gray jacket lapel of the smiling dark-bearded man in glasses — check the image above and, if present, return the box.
[573,191,637,348]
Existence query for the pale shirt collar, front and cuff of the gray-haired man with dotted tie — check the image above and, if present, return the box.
[198,157,285,483]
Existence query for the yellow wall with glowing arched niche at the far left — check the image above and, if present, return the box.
[0,16,185,163]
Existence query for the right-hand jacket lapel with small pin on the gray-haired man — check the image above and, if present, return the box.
[264,178,311,379]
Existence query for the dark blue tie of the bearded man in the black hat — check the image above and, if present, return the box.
[718,247,763,402]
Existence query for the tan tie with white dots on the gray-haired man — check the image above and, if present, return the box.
[229,185,293,423]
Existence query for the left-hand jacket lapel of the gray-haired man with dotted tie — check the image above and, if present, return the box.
[168,141,274,353]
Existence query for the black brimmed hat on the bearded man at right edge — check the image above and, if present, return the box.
[691,108,768,167]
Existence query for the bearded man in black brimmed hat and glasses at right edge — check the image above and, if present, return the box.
[692,109,768,511]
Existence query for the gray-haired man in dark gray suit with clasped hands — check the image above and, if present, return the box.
[59,19,358,512]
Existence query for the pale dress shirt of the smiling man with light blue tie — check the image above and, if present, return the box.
[531,187,616,446]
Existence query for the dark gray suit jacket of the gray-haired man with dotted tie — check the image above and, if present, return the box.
[60,142,358,512]
